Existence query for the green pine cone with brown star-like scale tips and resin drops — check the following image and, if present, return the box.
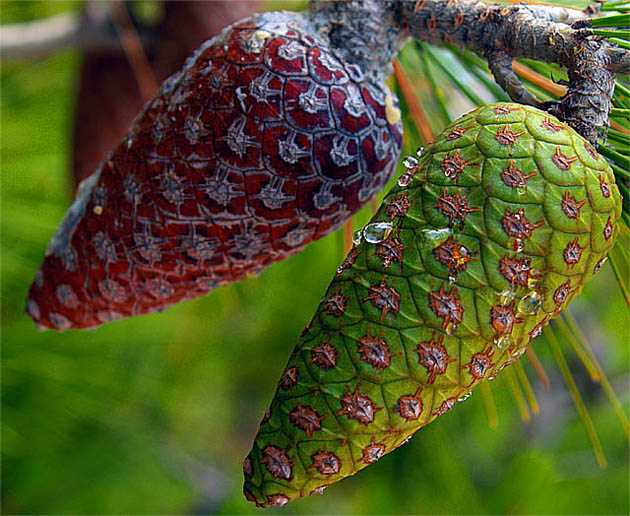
[243,103,621,507]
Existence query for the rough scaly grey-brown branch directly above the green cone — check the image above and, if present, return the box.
[399,0,630,143]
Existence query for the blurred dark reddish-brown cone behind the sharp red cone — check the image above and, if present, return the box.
[72,0,260,185]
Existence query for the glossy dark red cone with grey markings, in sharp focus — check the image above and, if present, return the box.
[27,13,402,330]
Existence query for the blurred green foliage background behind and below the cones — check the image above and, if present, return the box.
[0,1,630,514]
